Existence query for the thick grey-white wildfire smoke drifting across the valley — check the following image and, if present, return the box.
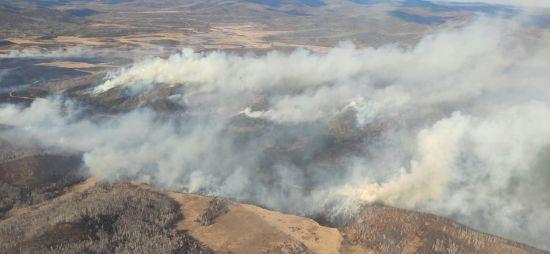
[0,19,550,249]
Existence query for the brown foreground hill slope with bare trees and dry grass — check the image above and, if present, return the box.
[0,179,544,253]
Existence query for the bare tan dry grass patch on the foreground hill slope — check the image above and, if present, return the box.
[169,193,341,253]
